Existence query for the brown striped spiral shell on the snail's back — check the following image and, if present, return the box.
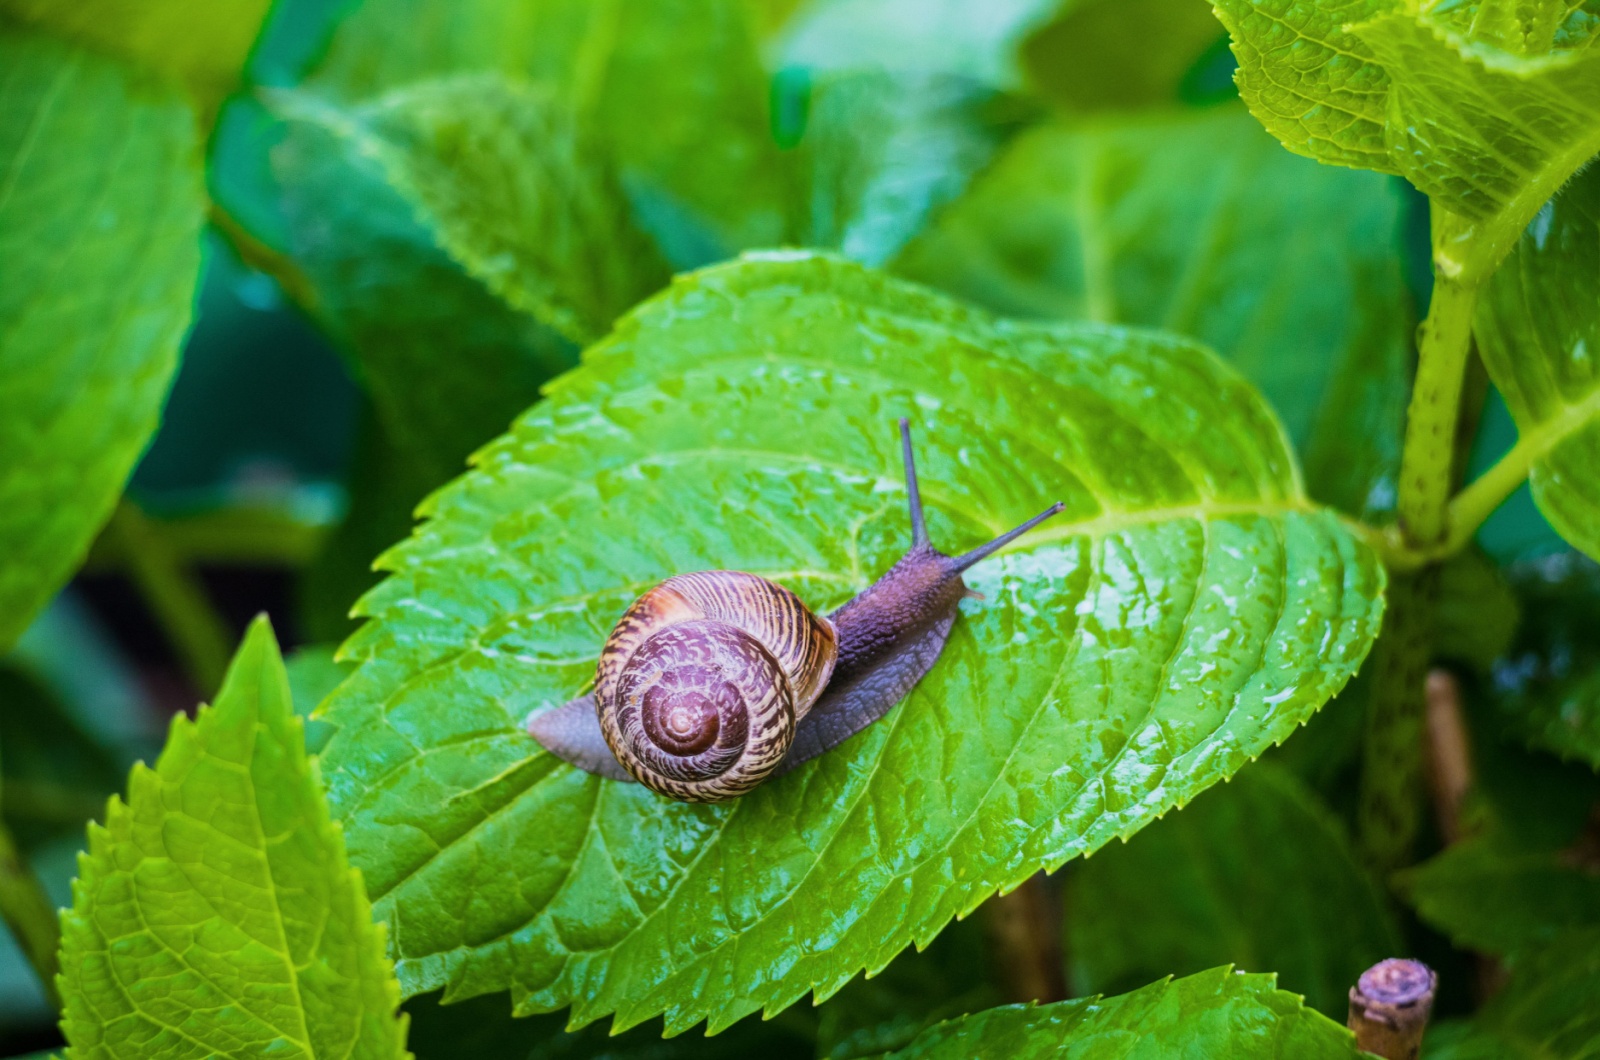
[595,570,838,802]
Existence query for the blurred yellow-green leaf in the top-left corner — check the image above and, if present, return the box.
[0,0,272,112]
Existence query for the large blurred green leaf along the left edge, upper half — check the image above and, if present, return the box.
[0,27,205,648]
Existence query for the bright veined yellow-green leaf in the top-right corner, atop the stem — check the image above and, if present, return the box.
[1216,0,1600,277]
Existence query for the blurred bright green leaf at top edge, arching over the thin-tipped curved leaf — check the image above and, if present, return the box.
[310,0,790,267]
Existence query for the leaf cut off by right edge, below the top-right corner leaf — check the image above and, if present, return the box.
[1474,164,1600,559]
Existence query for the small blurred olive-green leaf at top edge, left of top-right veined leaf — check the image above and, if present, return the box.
[1021,0,1224,114]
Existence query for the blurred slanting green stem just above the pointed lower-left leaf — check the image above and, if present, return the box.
[106,498,234,695]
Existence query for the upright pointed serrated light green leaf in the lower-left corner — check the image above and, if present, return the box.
[61,618,406,1060]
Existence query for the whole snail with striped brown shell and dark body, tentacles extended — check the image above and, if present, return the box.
[526,420,1062,802]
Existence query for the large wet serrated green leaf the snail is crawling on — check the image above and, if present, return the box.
[325,251,1382,1031]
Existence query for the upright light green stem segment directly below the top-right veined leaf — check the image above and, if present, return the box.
[1400,275,1478,551]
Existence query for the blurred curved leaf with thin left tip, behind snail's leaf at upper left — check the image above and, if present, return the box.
[282,74,667,344]
